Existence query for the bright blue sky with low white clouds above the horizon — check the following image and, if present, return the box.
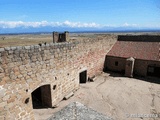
[0,0,160,33]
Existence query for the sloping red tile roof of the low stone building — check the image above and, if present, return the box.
[107,41,160,61]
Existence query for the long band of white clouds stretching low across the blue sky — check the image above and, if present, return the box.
[0,20,160,28]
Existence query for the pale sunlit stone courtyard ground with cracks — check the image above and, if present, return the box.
[34,73,160,120]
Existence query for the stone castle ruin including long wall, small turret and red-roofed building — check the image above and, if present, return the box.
[0,32,160,120]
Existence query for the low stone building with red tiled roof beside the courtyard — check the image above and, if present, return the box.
[105,35,160,77]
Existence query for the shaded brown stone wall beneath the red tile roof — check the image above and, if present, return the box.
[104,56,160,77]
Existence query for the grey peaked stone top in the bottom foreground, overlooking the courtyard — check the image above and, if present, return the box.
[48,102,112,120]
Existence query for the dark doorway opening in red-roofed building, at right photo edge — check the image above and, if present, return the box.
[147,66,160,78]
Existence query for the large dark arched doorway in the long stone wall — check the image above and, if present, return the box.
[32,85,52,109]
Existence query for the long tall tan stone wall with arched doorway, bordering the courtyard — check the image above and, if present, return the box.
[0,37,116,120]
